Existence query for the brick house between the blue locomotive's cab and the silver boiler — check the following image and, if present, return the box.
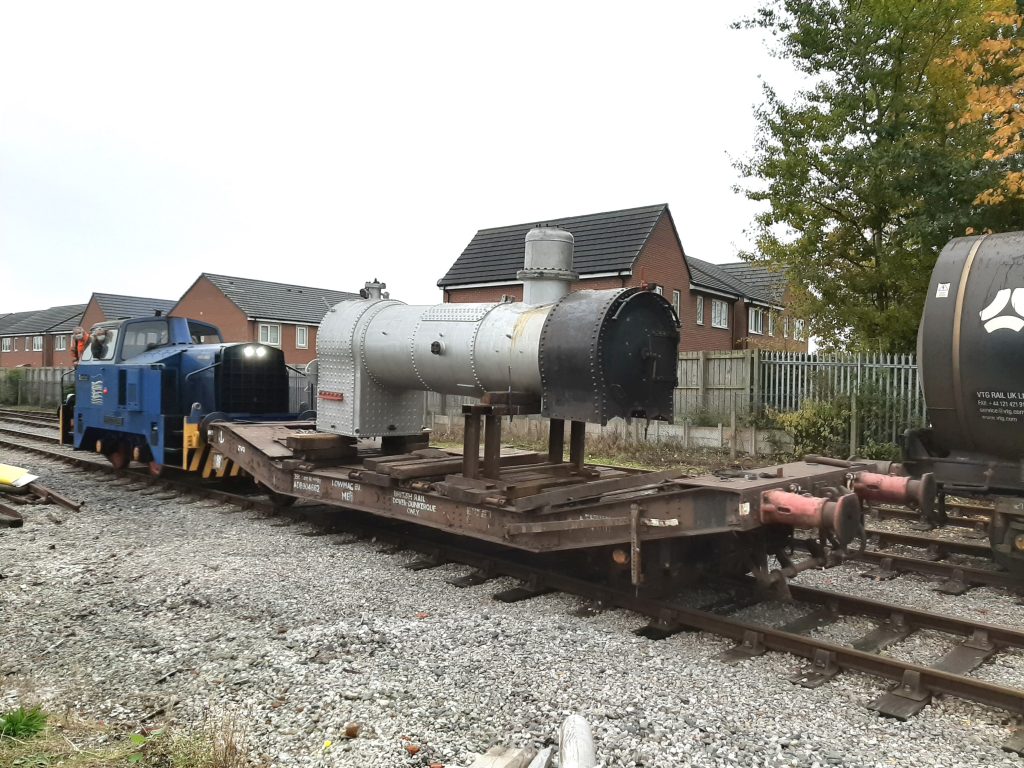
[170,272,358,365]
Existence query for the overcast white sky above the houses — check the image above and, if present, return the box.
[0,0,801,312]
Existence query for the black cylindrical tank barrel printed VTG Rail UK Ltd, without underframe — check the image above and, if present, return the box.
[918,232,1024,461]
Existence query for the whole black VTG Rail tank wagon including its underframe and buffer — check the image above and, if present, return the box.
[903,232,1024,574]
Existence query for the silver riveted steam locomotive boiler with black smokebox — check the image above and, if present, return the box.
[316,228,679,437]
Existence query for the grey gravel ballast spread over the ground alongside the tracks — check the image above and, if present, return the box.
[0,450,1024,768]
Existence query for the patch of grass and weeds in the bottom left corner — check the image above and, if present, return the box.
[0,710,250,768]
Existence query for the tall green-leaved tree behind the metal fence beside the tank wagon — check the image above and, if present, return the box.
[738,0,1024,351]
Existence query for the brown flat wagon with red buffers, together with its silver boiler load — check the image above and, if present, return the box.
[197,228,930,586]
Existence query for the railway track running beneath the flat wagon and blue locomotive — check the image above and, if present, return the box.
[0,434,1024,752]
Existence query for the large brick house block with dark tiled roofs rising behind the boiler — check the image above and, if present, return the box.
[437,204,807,351]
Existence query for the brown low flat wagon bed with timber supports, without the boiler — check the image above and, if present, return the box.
[206,406,873,567]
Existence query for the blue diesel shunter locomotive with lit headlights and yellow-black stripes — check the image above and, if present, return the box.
[60,316,295,477]
